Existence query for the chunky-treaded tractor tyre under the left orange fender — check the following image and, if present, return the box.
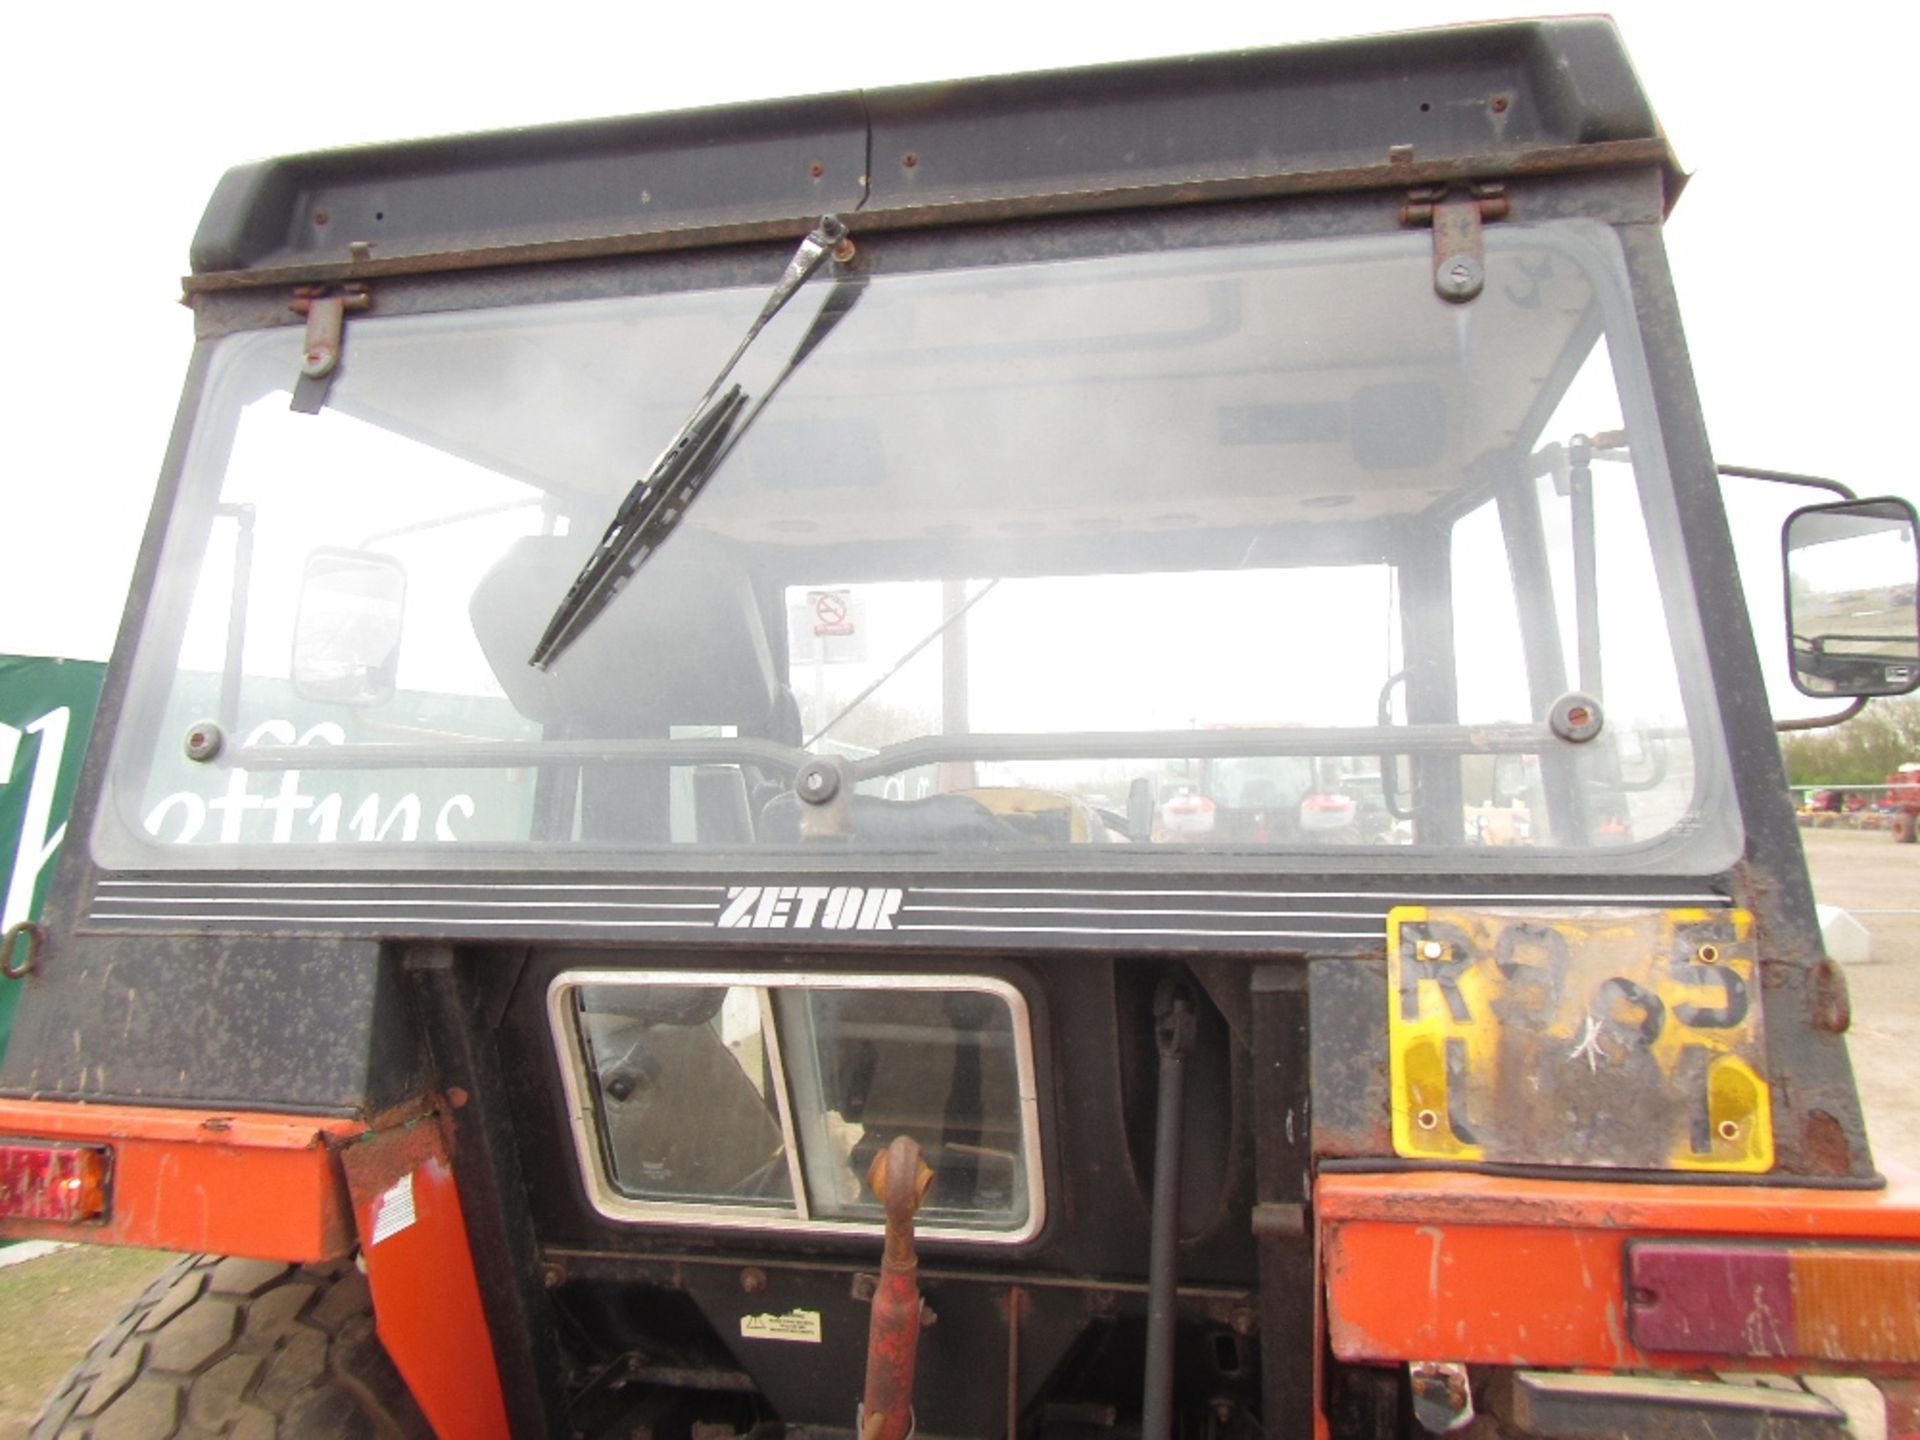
[31,1256,432,1440]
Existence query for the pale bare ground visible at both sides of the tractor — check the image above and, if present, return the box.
[0,829,1920,1440]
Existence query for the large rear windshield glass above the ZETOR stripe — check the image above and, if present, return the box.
[96,225,1732,868]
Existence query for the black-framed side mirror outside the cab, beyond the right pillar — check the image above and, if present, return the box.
[1782,497,1920,697]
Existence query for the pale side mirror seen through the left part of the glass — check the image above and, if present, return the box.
[292,549,407,707]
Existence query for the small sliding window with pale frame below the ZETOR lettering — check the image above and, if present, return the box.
[549,972,1043,1242]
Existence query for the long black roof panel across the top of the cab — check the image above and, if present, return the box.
[188,17,1670,290]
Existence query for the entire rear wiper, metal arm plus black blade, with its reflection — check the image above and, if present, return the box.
[528,215,852,670]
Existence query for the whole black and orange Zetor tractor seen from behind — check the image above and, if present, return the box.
[0,19,1920,1440]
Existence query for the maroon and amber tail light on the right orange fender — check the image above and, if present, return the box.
[1626,1240,1920,1365]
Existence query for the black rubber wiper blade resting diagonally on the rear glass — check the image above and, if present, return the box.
[528,386,747,670]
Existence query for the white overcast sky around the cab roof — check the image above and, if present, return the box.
[0,0,1920,657]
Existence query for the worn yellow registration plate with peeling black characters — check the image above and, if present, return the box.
[1386,904,1774,1171]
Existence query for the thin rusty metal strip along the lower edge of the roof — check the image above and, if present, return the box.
[180,136,1686,301]
